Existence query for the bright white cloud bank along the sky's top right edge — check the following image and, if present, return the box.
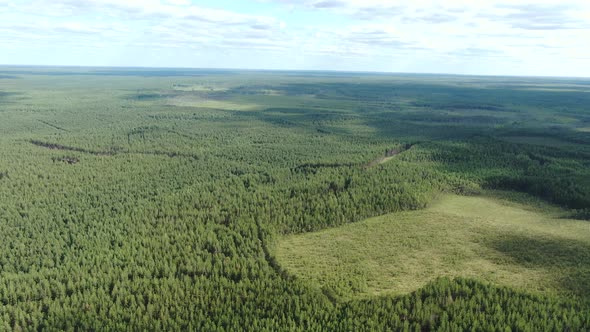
[267,0,590,30]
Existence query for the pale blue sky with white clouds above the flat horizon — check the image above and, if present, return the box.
[0,0,590,77]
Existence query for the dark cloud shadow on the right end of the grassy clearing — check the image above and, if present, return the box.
[488,234,590,296]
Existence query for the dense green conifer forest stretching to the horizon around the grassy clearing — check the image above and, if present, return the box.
[0,67,590,331]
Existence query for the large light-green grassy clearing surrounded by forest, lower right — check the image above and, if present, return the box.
[275,193,590,299]
